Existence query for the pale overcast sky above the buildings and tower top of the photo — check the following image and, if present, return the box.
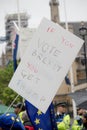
[0,0,87,36]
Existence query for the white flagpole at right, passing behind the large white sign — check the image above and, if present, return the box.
[63,0,77,118]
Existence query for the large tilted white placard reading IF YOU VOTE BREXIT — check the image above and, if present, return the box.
[9,18,83,113]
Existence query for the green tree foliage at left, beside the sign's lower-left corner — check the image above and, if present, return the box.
[0,62,22,105]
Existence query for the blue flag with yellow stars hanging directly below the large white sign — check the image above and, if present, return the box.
[25,101,57,130]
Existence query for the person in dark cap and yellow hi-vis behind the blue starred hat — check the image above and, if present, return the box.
[13,103,25,122]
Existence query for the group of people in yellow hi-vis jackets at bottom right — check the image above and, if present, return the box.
[56,102,87,130]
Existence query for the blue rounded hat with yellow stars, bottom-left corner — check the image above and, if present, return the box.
[0,113,25,130]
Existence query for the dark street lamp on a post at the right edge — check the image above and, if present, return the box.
[79,22,87,81]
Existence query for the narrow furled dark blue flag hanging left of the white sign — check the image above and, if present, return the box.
[13,34,19,71]
